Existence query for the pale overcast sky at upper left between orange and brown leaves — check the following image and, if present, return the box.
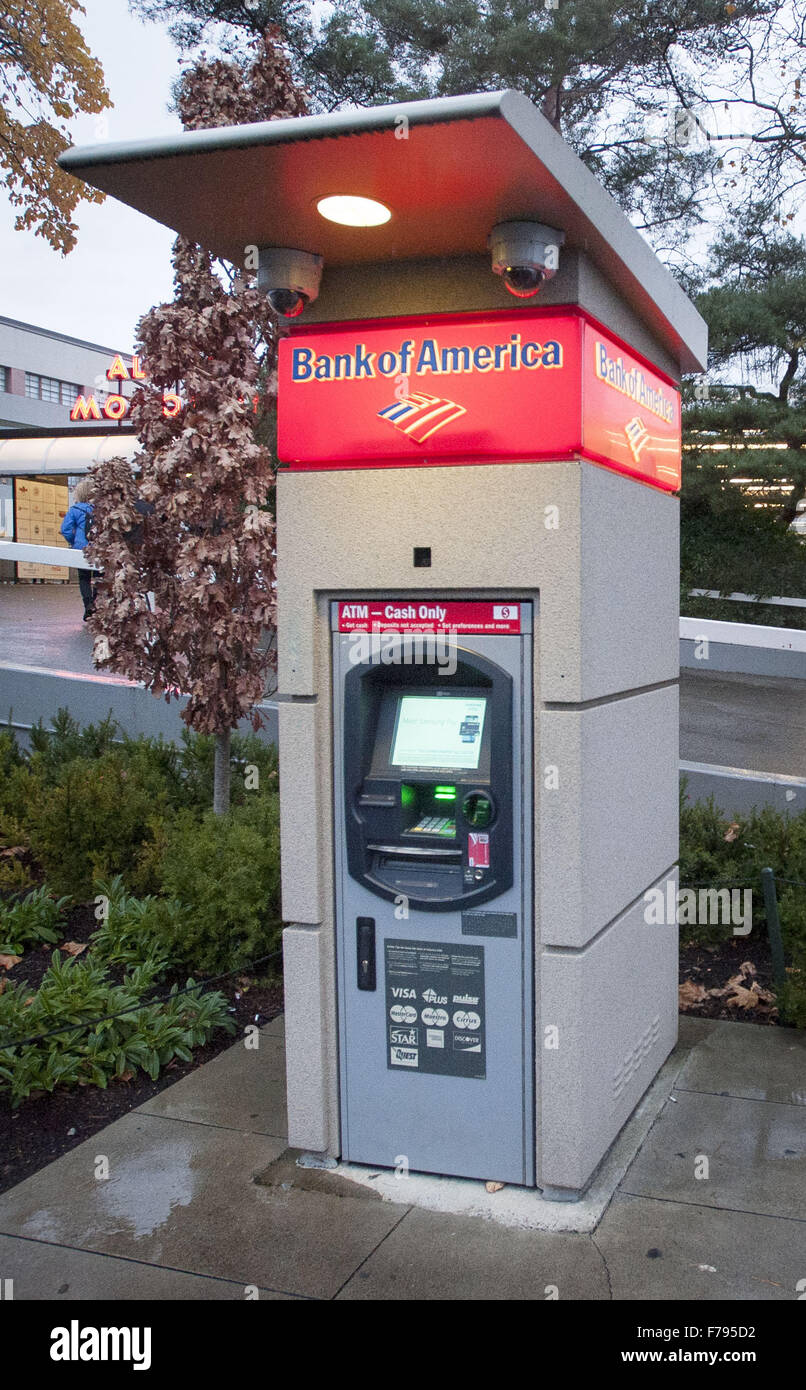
[0,0,181,352]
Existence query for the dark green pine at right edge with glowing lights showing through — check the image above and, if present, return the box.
[682,212,806,617]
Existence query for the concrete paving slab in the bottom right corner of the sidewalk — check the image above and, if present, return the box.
[593,1183,806,1295]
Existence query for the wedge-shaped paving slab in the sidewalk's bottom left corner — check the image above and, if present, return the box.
[0,1236,297,1302]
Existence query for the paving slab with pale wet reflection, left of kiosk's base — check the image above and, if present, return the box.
[0,1111,403,1298]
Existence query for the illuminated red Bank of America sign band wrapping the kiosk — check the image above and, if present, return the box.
[278,306,681,492]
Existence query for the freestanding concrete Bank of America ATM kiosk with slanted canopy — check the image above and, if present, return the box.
[63,93,706,1197]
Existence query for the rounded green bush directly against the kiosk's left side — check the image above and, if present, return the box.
[154,792,281,974]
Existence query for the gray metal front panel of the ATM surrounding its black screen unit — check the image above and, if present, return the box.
[334,617,535,1184]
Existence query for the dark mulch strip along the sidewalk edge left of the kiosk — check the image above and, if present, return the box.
[0,906,282,1193]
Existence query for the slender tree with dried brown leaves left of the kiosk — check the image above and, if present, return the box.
[88,31,306,813]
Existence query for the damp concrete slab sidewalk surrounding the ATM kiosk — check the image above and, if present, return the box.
[0,1019,806,1301]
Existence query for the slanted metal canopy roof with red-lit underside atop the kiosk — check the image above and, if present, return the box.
[60,92,707,371]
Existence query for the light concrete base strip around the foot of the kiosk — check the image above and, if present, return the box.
[330,1030,699,1233]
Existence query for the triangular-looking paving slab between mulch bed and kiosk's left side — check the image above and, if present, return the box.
[139,1031,288,1140]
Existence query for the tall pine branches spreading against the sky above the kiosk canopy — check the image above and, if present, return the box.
[131,0,806,250]
